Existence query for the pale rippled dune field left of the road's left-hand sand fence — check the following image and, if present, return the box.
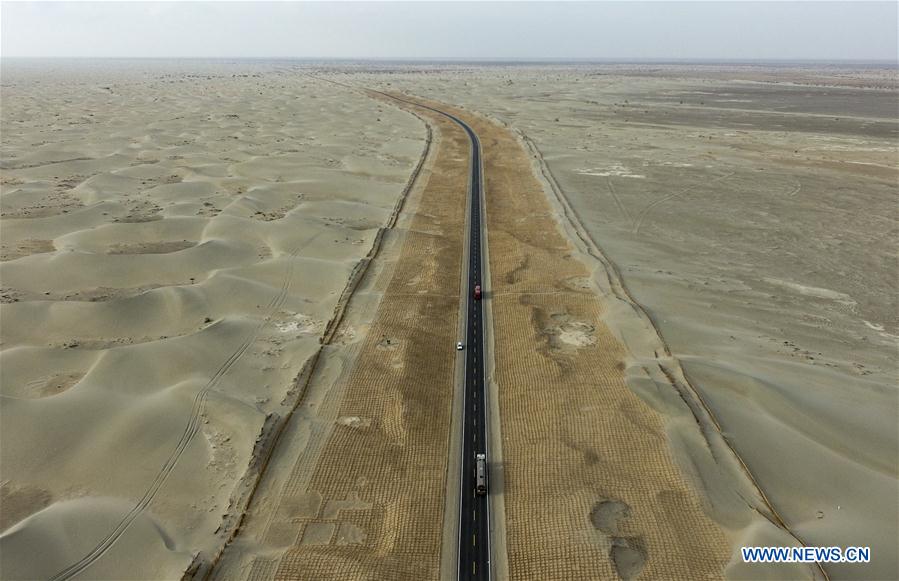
[0,61,426,579]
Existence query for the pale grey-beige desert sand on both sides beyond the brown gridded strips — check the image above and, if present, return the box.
[0,57,899,579]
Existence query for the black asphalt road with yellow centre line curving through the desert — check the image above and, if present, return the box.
[376,91,490,580]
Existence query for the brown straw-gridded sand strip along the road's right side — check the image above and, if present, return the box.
[446,104,728,580]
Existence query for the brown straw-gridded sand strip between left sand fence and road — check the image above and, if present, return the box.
[212,90,468,581]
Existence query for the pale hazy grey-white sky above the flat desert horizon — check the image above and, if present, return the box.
[0,1,899,61]
